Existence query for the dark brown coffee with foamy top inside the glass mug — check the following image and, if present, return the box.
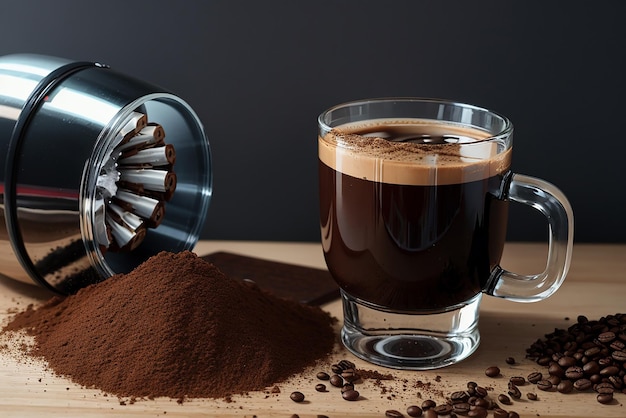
[318,119,511,312]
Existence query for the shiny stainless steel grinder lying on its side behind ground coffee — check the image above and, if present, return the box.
[0,54,212,294]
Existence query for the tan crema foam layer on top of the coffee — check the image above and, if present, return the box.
[318,119,511,185]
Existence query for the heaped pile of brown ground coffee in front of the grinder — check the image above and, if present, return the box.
[4,251,335,399]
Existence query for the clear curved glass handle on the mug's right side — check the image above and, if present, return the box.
[485,174,574,302]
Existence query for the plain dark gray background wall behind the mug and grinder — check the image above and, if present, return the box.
[0,0,626,242]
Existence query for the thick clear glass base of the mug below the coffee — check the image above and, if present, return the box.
[341,292,481,370]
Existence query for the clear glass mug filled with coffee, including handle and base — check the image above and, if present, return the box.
[318,98,573,370]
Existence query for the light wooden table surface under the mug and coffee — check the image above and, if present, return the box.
[0,241,626,418]
